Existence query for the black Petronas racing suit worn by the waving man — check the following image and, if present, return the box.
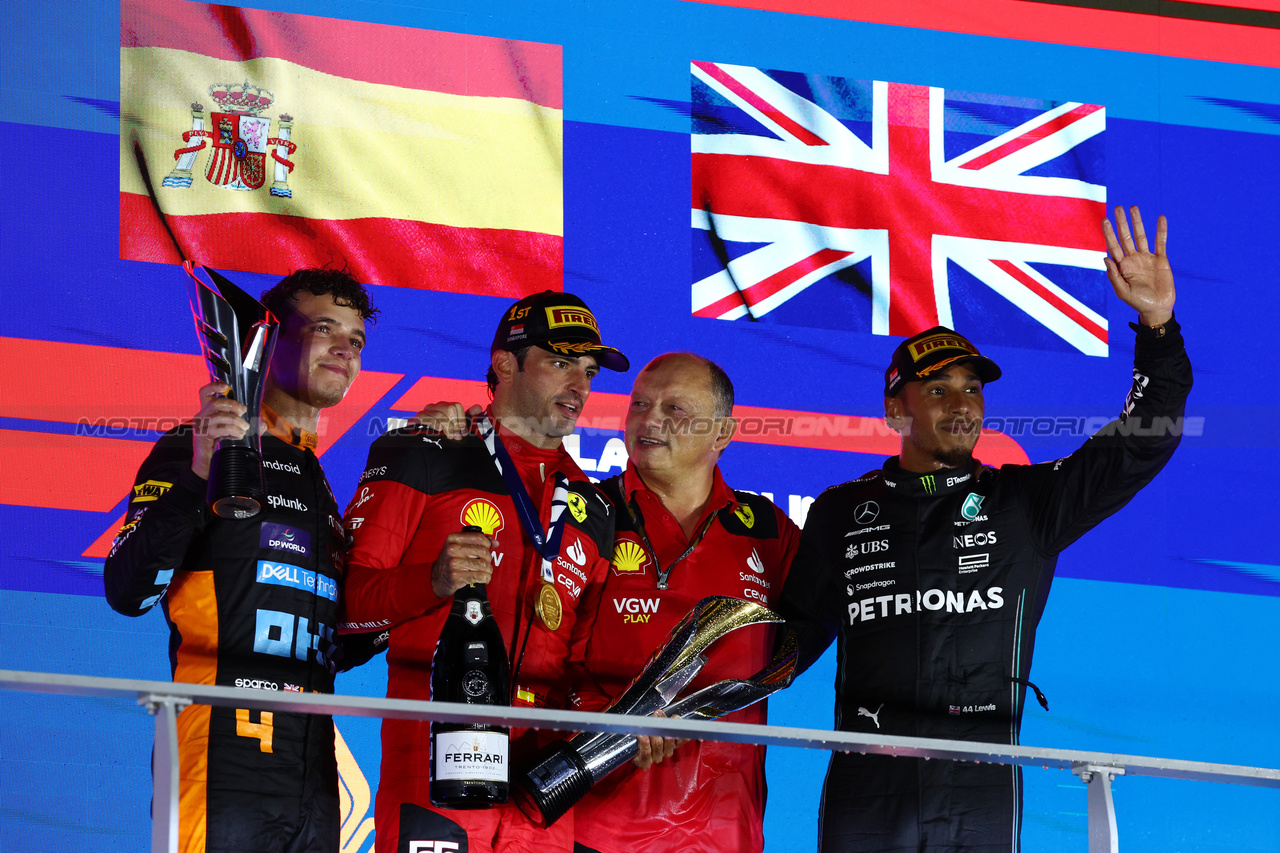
[783,320,1192,853]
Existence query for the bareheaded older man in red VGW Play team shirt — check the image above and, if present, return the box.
[568,352,800,853]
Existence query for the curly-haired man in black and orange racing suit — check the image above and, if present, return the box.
[104,270,376,853]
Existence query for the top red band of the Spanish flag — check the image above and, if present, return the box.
[120,0,563,109]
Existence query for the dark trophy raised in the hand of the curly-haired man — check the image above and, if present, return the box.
[183,261,279,519]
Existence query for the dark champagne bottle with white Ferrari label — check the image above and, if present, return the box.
[431,525,511,808]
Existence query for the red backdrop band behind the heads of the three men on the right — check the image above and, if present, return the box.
[390,377,1028,467]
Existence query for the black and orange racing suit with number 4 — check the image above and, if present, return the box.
[105,409,363,853]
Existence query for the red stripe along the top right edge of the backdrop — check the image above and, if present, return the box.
[687,0,1280,68]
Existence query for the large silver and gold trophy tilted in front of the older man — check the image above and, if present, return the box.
[512,596,796,826]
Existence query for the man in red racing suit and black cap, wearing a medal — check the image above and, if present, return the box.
[343,291,628,853]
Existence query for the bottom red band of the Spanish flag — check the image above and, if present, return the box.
[120,192,564,298]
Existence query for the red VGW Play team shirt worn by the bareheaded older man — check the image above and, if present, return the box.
[573,465,800,853]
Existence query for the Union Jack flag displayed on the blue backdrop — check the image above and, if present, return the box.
[691,61,1110,356]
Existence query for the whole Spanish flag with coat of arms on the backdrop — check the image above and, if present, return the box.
[120,0,564,297]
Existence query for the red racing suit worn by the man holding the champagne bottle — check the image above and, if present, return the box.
[343,428,613,853]
